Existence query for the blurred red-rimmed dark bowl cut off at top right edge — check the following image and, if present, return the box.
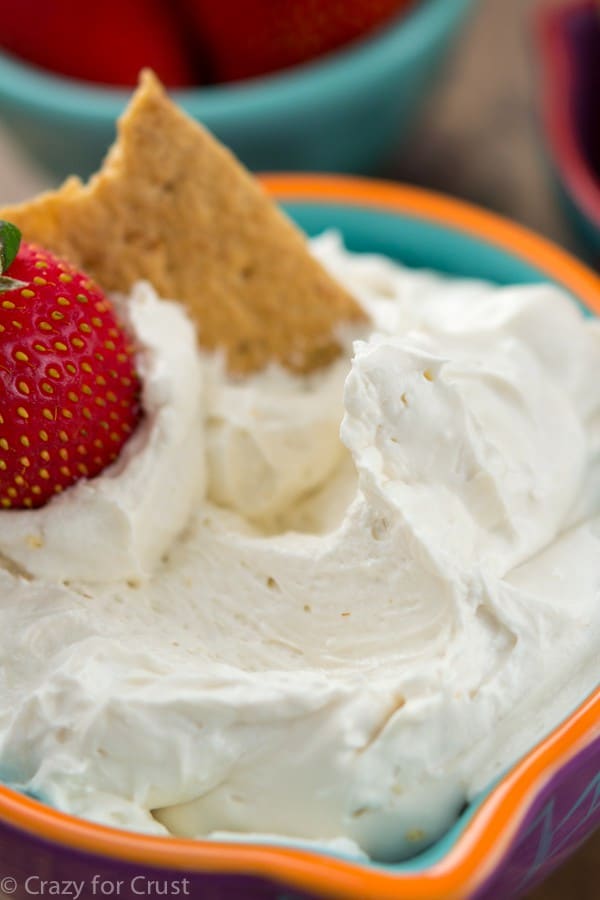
[536,0,600,262]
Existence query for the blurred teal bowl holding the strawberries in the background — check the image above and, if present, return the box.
[0,0,473,178]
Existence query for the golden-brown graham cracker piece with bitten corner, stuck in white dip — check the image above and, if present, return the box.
[0,71,364,373]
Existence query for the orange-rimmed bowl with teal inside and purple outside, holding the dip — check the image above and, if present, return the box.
[0,175,600,900]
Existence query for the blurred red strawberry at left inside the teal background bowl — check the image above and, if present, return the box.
[0,0,197,87]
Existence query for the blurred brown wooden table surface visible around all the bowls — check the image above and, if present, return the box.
[0,0,600,900]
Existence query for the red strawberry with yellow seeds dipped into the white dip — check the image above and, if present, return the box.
[0,222,141,509]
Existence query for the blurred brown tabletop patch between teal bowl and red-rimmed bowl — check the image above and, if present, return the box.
[390,0,582,250]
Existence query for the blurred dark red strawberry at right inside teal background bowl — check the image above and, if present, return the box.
[181,0,412,81]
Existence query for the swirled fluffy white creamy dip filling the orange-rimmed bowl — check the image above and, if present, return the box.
[0,235,600,859]
